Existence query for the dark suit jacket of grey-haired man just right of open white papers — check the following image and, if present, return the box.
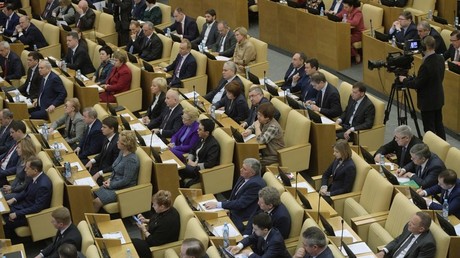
[222,175,266,232]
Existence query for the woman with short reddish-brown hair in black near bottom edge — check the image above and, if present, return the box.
[132,190,181,257]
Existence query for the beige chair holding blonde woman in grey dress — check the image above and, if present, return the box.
[104,147,152,218]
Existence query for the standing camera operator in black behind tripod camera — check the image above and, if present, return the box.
[399,36,446,140]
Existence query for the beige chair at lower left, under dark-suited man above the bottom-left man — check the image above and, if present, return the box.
[14,168,64,242]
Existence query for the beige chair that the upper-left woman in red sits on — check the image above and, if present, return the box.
[114,62,142,112]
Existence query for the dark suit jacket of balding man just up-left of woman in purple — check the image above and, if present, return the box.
[147,104,183,138]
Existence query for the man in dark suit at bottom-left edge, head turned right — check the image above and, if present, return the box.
[36,207,82,258]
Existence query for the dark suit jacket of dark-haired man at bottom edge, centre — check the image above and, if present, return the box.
[240,228,291,258]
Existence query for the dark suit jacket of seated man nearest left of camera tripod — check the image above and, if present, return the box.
[340,95,375,131]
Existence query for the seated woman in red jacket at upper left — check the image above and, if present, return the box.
[99,52,132,103]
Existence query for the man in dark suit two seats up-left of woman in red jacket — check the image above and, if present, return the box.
[65,31,95,74]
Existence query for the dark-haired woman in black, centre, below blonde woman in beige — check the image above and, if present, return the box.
[214,81,249,123]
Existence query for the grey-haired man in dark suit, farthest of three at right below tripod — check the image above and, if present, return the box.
[374,125,422,168]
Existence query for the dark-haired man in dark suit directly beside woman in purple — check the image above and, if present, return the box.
[179,119,220,187]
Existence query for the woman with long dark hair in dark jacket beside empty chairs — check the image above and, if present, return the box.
[319,139,356,196]
